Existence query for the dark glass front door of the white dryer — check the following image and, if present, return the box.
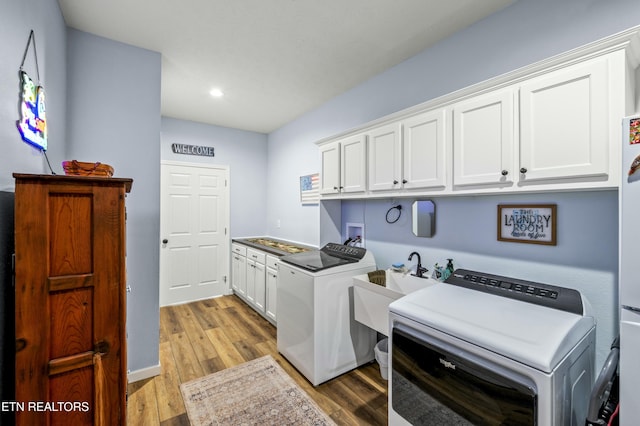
[391,324,537,425]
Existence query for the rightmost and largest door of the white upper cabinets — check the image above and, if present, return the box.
[520,58,610,182]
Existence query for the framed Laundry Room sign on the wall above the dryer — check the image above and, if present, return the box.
[498,204,557,246]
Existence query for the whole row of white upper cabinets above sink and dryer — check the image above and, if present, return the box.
[319,30,640,198]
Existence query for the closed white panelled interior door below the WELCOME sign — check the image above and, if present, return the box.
[160,162,230,306]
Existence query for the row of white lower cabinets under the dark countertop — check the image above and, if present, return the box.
[231,243,278,324]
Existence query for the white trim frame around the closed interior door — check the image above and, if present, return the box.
[158,160,233,301]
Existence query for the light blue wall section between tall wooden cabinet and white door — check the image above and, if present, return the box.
[66,29,161,371]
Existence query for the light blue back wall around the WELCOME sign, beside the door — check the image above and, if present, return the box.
[161,117,267,238]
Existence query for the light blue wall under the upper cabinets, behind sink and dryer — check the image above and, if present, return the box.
[342,191,618,362]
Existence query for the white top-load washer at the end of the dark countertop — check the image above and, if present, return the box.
[277,244,376,386]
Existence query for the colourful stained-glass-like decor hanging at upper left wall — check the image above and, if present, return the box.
[16,30,47,151]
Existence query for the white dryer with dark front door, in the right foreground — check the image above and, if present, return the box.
[389,269,596,426]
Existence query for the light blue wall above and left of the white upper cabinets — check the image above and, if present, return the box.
[267,0,640,244]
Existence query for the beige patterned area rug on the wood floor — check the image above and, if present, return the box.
[180,355,335,426]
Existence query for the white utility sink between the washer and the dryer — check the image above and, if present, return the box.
[353,269,438,336]
